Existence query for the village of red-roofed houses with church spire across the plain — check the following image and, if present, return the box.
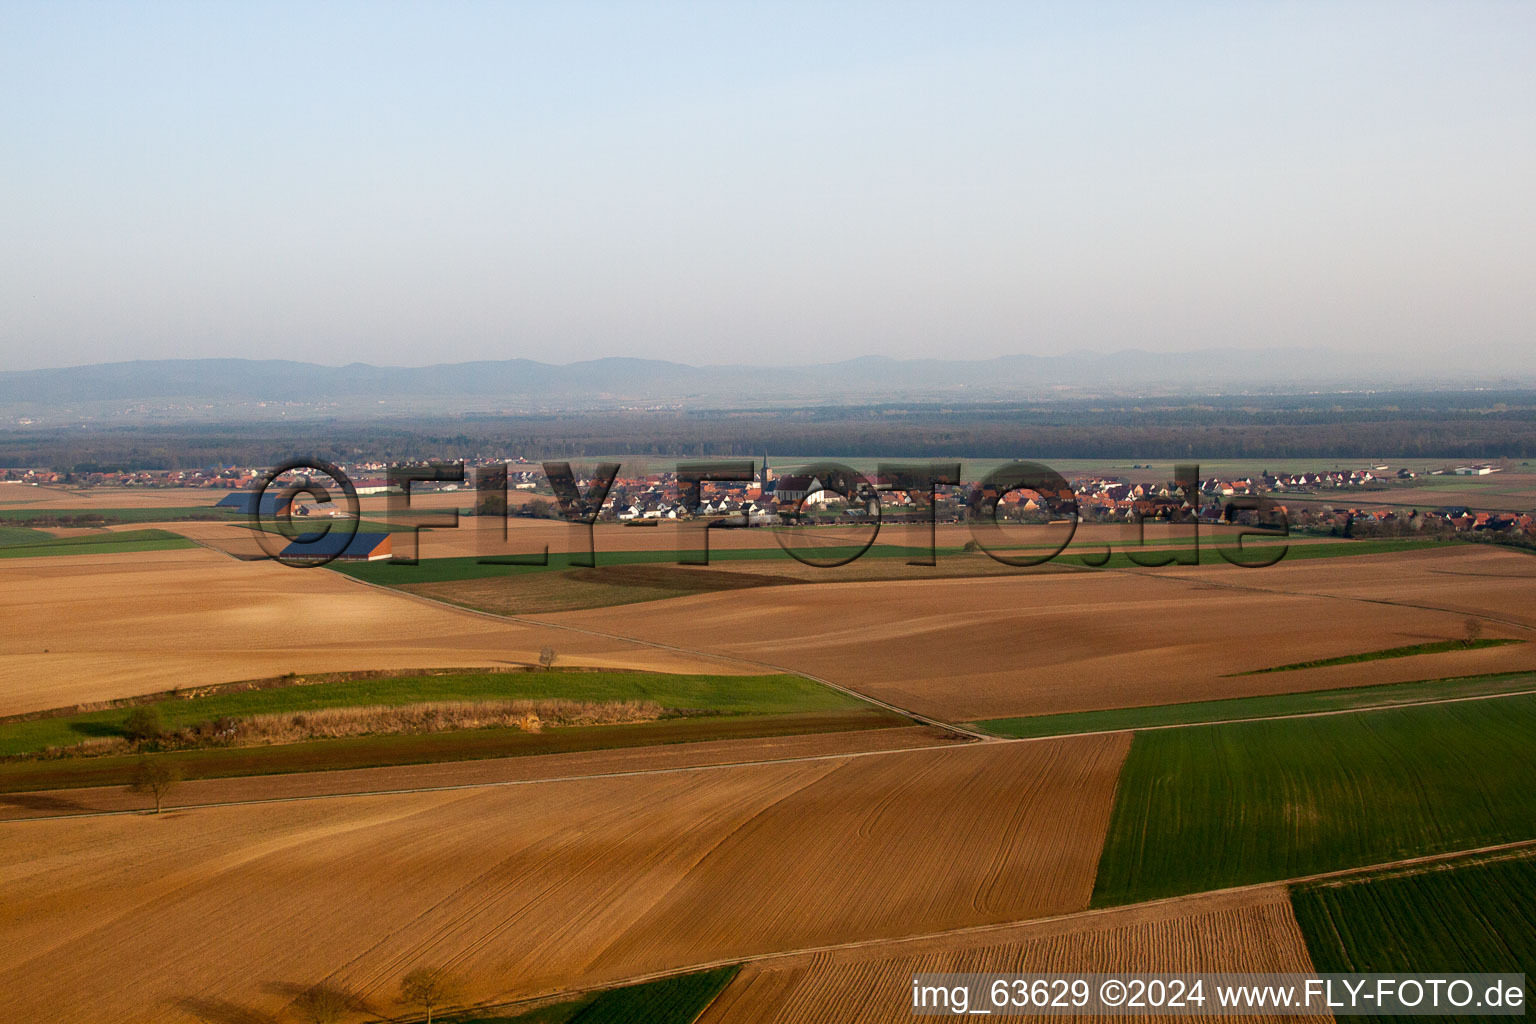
[0,456,1536,542]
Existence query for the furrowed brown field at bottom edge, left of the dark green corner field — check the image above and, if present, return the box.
[699,886,1312,1024]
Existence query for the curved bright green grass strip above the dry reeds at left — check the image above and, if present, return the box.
[0,671,862,757]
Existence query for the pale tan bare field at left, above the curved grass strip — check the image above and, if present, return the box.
[0,550,739,714]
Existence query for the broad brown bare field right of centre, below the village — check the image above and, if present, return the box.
[544,551,1536,722]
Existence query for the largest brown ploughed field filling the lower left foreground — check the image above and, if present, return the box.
[0,737,1126,1024]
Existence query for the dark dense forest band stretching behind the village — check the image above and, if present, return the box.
[0,391,1536,471]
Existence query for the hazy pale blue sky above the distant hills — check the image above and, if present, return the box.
[0,0,1536,368]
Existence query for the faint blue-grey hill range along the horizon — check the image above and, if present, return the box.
[0,348,1533,416]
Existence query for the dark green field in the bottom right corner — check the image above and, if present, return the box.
[1292,854,1536,1021]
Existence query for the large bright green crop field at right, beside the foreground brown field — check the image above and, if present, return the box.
[1094,695,1536,906]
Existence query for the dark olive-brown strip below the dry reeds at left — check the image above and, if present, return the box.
[0,708,911,792]
